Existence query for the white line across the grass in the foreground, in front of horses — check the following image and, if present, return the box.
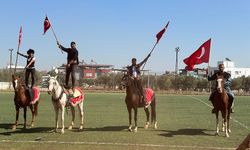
[0,140,235,150]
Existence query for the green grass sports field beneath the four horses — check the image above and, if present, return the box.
[0,92,250,150]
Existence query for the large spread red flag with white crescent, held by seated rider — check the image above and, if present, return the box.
[183,39,211,70]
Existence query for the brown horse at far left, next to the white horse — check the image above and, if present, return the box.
[12,75,39,130]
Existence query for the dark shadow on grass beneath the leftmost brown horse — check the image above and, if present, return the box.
[0,124,54,136]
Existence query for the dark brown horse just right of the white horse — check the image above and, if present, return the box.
[122,74,157,132]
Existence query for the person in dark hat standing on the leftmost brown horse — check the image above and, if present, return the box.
[17,49,36,101]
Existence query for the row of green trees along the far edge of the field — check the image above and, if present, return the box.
[0,69,250,92]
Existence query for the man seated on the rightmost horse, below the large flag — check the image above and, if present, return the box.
[208,64,234,113]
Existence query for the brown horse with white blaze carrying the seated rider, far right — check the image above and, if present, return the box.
[212,75,231,137]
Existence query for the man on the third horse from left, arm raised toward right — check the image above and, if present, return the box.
[127,53,151,104]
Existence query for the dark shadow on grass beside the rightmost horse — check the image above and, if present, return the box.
[159,129,214,137]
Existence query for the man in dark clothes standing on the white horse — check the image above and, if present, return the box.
[57,42,79,92]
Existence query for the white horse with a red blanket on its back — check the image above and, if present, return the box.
[48,76,84,133]
